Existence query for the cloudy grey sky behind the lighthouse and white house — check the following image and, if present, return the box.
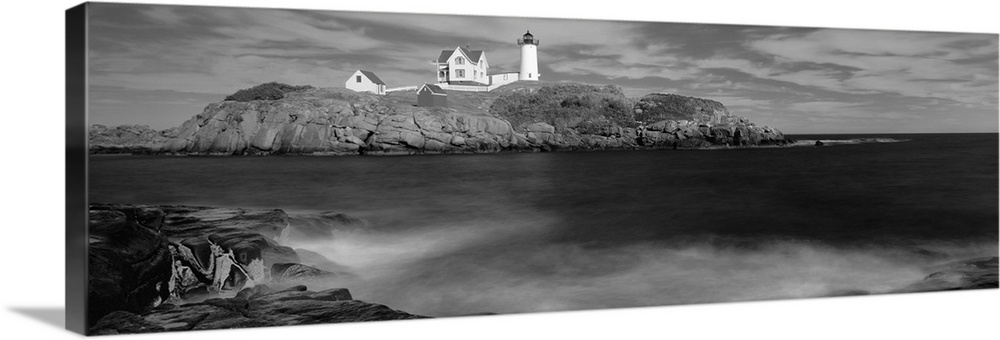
[88,3,1000,134]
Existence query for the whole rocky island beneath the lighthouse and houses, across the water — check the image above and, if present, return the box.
[91,83,786,155]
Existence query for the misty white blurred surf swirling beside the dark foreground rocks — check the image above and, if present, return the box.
[284,209,996,316]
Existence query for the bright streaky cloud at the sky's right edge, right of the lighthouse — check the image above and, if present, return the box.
[749,29,997,105]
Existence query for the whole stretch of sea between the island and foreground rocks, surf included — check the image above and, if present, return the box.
[90,134,998,316]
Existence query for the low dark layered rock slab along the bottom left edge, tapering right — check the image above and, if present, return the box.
[90,286,426,335]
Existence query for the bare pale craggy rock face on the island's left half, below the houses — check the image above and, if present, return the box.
[154,89,511,154]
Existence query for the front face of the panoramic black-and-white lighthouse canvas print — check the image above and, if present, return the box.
[71,3,998,335]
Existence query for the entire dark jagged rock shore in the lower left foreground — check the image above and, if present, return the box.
[88,204,421,334]
